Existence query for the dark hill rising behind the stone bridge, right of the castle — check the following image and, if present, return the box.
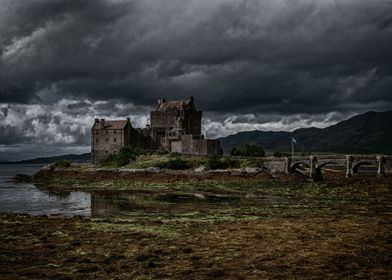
[219,111,392,154]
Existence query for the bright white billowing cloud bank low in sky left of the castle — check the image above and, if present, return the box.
[0,99,150,150]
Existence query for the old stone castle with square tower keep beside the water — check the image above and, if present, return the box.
[91,97,222,164]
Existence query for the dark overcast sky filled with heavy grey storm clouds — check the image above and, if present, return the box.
[0,0,392,160]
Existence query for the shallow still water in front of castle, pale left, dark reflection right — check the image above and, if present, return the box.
[0,164,286,217]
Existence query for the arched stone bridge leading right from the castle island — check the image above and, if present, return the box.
[263,155,392,181]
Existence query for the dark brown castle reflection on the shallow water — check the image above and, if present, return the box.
[91,191,288,217]
